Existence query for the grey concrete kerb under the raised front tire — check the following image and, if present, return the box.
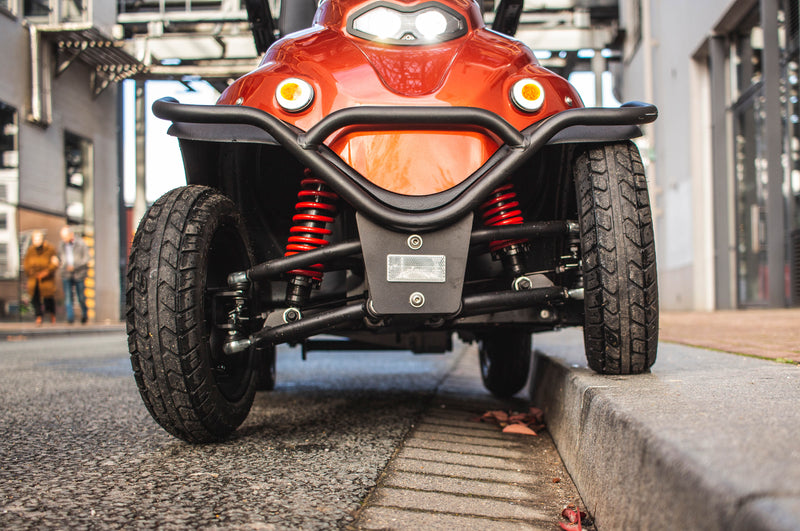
[531,330,800,530]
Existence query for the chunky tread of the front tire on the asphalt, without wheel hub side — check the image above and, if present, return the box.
[126,186,253,443]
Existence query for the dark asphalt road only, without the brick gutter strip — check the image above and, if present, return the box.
[0,334,462,529]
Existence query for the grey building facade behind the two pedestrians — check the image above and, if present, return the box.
[0,0,135,320]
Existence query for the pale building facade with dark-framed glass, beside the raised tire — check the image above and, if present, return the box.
[620,0,800,310]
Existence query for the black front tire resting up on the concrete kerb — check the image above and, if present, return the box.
[573,142,658,374]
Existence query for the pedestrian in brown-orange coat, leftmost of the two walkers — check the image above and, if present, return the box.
[22,231,58,325]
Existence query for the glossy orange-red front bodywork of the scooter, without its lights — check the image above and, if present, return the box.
[219,0,581,195]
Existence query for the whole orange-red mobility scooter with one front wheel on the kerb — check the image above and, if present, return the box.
[127,0,658,442]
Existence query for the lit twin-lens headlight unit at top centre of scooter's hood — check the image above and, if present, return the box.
[347,2,467,46]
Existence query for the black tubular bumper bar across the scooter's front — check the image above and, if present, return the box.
[153,98,658,231]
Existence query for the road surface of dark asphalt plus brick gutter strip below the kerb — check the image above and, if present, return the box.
[0,333,588,530]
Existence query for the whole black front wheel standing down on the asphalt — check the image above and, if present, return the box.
[126,186,257,443]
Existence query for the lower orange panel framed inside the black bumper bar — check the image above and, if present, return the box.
[331,131,498,195]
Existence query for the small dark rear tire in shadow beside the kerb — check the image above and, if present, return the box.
[478,332,531,398]
